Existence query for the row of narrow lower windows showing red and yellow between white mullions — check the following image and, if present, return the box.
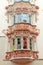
[12,36,33,50]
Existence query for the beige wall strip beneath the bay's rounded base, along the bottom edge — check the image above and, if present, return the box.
[0,60,43,65]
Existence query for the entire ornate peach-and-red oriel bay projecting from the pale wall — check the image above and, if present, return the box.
[4,0,39,63]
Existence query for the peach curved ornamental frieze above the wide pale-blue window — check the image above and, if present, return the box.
[6,2,39,12]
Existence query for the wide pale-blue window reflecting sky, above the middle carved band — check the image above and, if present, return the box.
[15,14,31,24]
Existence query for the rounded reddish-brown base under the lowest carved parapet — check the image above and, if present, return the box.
[4,57,34,64]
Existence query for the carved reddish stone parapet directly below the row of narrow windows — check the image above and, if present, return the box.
[5,50,38,60]
